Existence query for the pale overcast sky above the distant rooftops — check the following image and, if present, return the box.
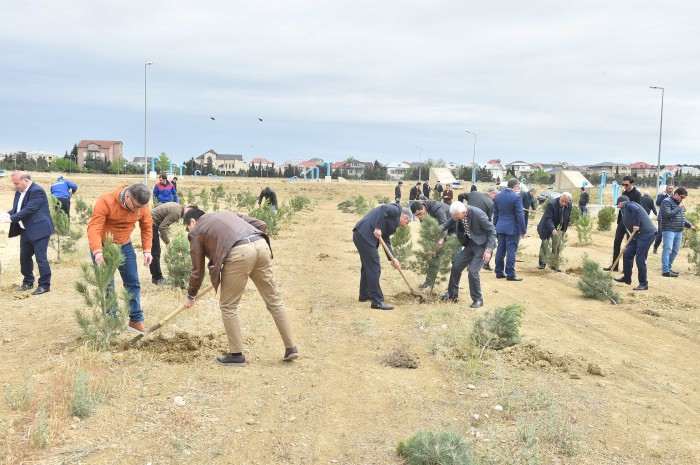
[0,0,700,165]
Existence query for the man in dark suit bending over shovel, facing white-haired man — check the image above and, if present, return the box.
[352,203,412,310]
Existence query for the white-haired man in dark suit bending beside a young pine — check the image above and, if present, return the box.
[440,201,496,308]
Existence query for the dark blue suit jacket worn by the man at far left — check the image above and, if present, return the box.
[8,182,53,241]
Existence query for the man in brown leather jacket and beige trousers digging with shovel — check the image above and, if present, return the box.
[184,207,299,366]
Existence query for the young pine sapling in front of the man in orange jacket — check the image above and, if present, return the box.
[75,235,131,350]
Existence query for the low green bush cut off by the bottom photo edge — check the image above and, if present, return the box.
[396,431,479,465]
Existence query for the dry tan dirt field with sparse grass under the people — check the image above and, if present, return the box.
[0,175,700,465]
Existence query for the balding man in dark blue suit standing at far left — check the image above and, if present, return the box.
[1,171,53,295]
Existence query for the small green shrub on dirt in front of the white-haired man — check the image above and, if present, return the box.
[470,304,525,356]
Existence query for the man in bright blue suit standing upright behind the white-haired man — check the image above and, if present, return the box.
[493,178,527,281]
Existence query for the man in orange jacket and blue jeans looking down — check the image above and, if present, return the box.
[87,184,153,334]
